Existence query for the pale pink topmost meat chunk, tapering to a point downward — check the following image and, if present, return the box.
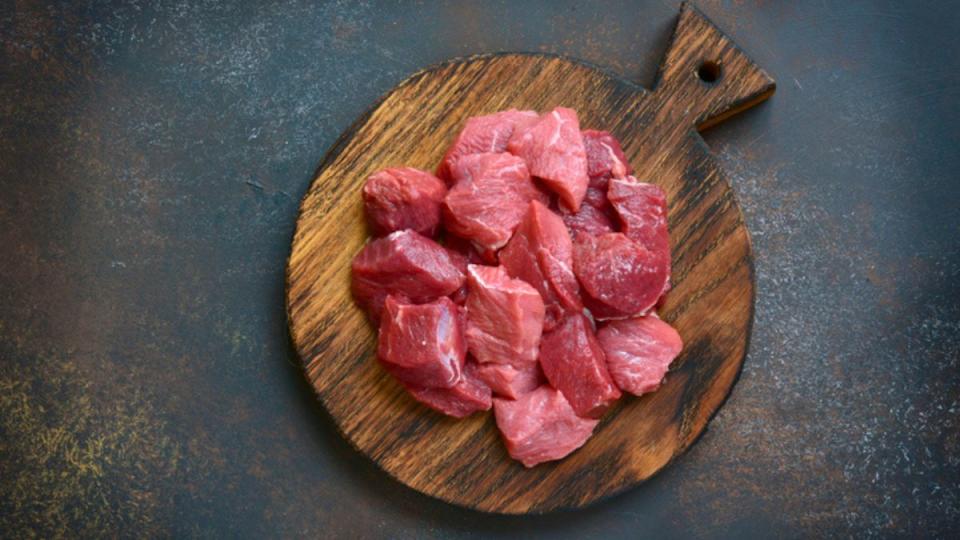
[507,107,589,211]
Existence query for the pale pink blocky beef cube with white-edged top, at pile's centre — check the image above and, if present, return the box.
[466,264,543,367]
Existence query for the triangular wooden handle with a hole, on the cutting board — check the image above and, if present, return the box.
[654,3,776,130]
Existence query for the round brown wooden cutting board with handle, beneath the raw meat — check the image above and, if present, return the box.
[287,2,775,514]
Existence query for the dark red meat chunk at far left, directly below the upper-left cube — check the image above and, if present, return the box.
[352,229,464,322]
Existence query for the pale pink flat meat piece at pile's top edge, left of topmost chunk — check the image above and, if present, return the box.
[437,109,539,181]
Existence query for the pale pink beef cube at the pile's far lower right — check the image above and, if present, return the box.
[597,315,683,396]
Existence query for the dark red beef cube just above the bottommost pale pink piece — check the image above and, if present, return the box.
[540,313,620,418]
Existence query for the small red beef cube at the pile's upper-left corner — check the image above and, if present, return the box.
[363,167,447,236]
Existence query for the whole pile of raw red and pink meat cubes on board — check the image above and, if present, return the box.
[353,107,683,467]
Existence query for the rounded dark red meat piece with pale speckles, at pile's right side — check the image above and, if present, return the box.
[573,233,670,320]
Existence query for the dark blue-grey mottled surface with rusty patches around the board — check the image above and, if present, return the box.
[0,0,960,537]
